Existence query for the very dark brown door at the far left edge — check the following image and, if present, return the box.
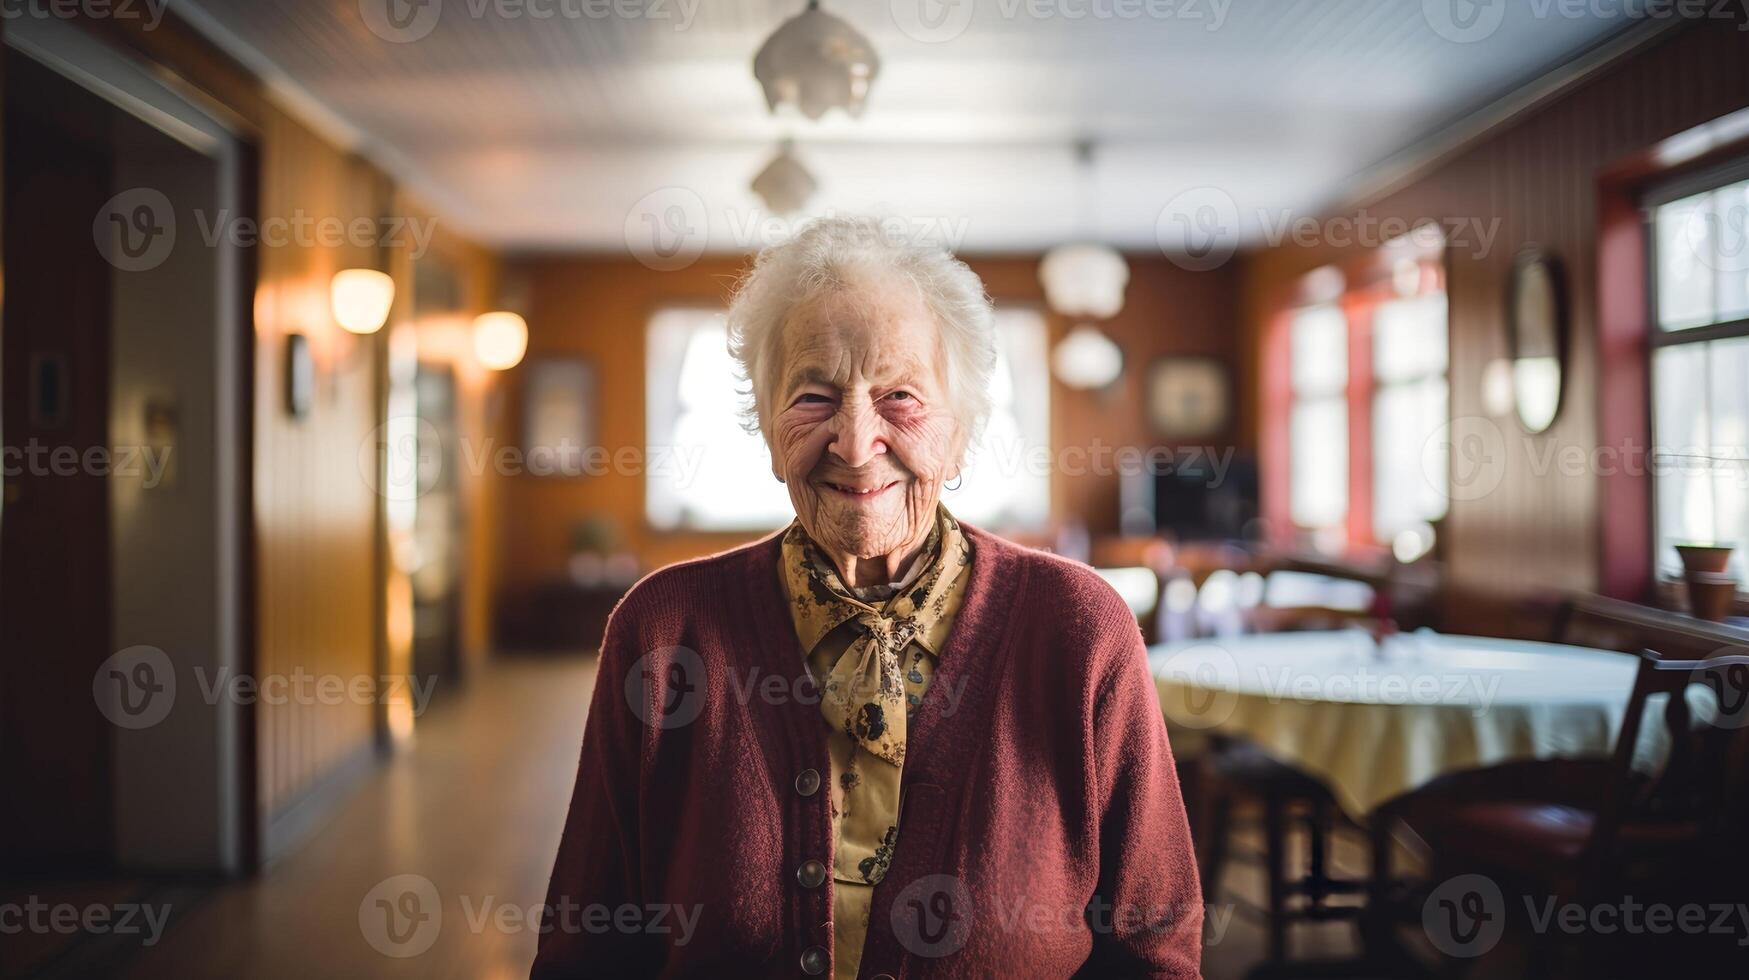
[0,53,114,870]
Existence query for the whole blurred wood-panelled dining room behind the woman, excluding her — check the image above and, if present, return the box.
[0,0,1749,978]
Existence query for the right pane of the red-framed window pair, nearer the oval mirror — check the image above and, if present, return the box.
[1373,292,1448,555]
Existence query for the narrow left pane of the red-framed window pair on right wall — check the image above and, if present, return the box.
[1287,305,1348,536]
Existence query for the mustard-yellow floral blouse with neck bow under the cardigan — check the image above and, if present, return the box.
[782,508,971,978]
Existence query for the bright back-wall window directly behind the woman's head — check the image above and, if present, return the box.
[644,306,1051,530]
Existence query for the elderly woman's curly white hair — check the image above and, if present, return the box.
[729,217,995,446]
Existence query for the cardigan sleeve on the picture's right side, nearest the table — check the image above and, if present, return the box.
[1081,611,1203,980]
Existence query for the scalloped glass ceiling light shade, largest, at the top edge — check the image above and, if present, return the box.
[754,7,880,119]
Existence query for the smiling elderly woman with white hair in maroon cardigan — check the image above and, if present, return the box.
[533,219,1202,978]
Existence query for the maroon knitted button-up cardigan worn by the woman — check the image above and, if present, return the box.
[532,525,1203,978]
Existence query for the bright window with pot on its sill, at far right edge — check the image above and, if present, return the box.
[1651,180,1749,579]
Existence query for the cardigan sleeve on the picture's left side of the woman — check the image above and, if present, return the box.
[530,602,661,980]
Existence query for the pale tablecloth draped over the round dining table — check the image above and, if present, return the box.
[1149,630,1660,817]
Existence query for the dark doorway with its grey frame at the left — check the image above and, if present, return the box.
[0,18,248,873]
